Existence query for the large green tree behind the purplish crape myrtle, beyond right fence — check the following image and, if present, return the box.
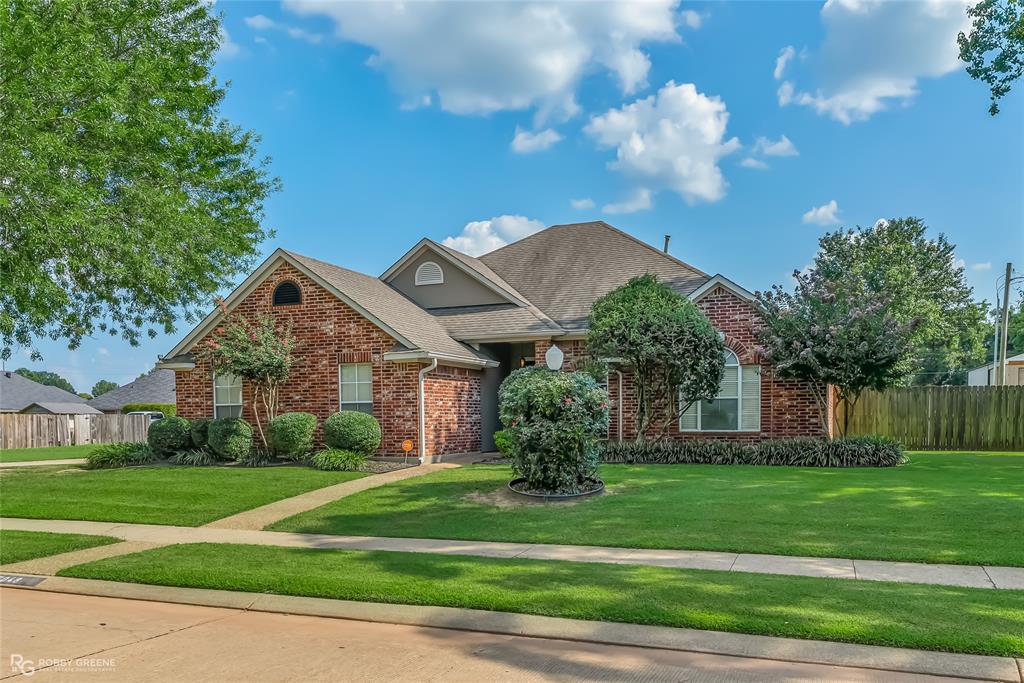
[812,217,986,377]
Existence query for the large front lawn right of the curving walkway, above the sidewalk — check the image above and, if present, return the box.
[270,453,1024,566]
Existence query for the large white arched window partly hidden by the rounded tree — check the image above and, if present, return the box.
[679,349,761,431]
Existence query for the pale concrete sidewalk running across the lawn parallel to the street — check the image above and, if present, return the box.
[0,518,1024,589]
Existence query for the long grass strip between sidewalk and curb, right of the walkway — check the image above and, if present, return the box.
[60,544,1024,656]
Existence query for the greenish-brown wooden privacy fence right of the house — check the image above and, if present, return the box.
[836,386,1024,451]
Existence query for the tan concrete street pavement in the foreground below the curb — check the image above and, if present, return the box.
[0,588,952,683]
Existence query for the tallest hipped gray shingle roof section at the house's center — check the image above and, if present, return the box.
[479,220,709,329]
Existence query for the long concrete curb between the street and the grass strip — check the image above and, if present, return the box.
[4,577,1024,683]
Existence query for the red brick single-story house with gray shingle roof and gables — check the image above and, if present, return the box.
[158,221,821,458]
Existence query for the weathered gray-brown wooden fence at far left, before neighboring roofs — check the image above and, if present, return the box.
[0,413,151,449]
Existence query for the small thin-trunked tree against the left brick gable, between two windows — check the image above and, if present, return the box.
[196,302,297,447]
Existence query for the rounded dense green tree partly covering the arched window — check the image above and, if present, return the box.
[587,274,725,441]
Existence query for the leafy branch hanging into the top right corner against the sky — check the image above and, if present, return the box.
[956,0,1024,116]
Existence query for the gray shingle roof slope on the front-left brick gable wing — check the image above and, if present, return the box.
[287,252,486,361]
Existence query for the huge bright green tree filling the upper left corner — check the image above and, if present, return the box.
[0,0,278,357]
